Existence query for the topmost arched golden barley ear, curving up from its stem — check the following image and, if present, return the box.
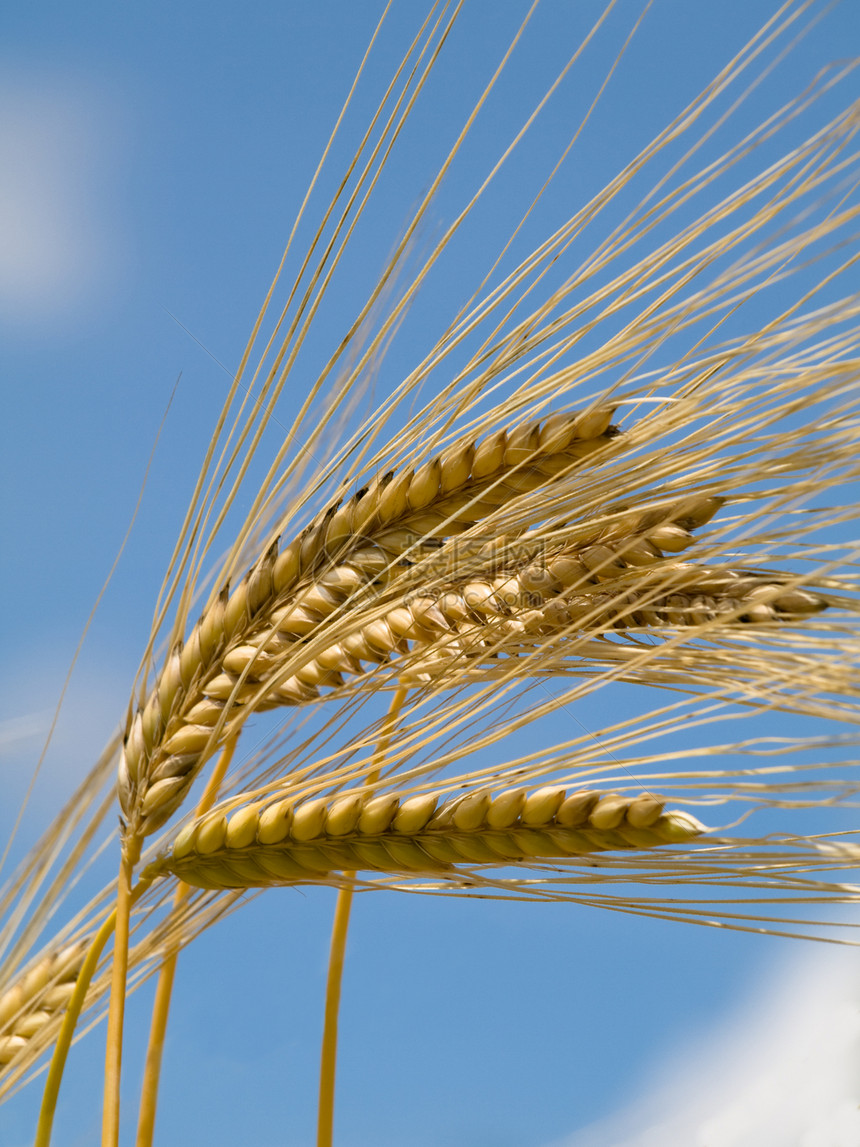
[117,408,618,836]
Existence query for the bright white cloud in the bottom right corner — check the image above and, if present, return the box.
[556,947,860,1147]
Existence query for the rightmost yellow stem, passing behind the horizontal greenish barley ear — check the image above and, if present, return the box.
[318,686,407,1147]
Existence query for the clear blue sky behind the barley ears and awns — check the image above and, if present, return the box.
[0,0,860,1147]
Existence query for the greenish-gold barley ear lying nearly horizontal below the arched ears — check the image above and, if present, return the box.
[150,786,706,889]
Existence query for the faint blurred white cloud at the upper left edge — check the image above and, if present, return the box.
[0,72,116,321]
